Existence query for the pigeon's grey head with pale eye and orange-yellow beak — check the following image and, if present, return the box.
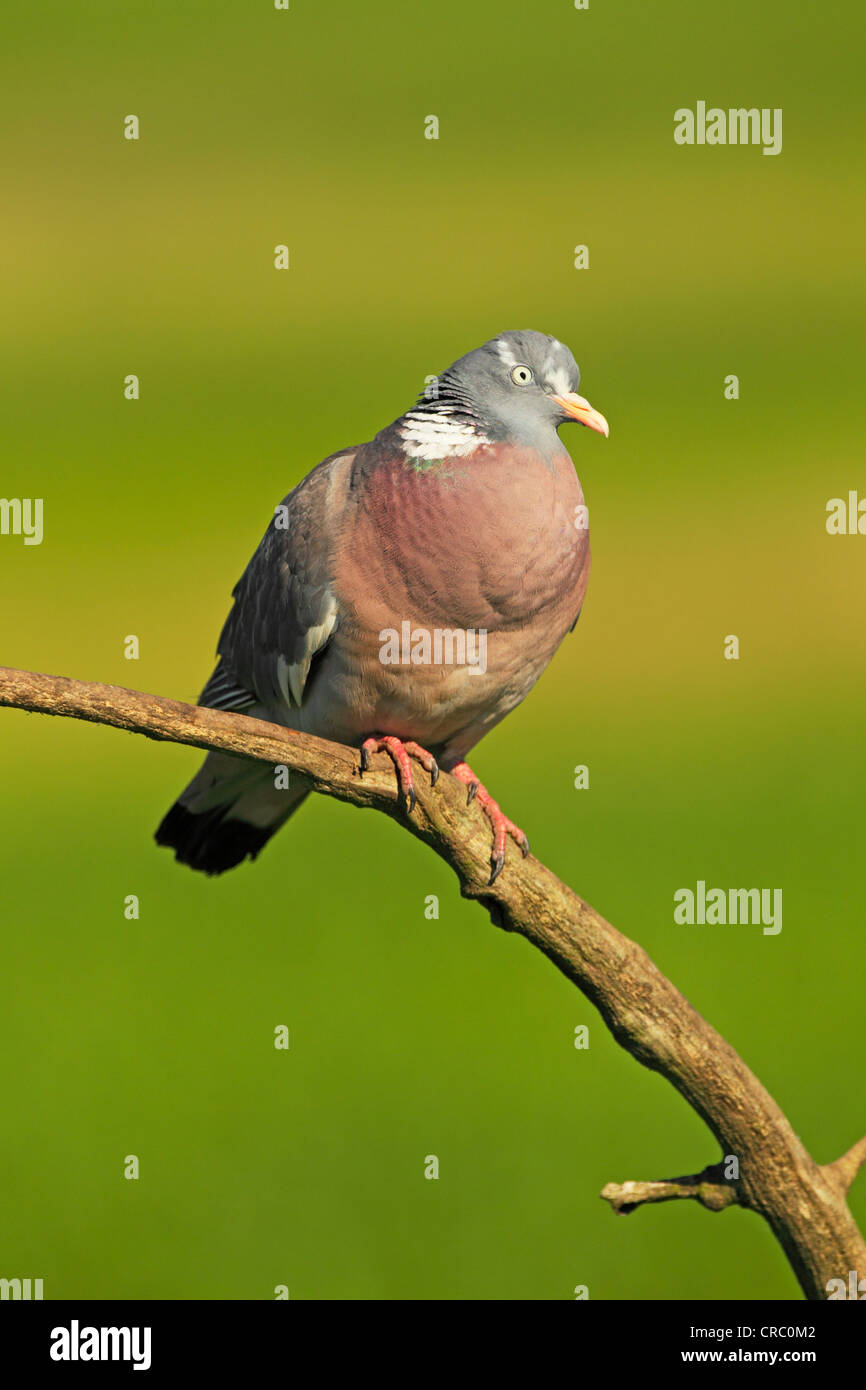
[416,329,607,452]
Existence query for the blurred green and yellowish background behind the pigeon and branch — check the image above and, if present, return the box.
[0,0,866,1300]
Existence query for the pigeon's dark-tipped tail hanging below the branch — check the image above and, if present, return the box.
[154,753,309,874]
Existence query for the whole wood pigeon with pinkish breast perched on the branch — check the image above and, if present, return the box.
[156,329,609,884]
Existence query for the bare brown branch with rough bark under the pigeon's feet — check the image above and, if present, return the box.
[0,667,866,1300]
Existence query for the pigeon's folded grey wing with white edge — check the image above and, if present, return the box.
[199,452,353,710]
